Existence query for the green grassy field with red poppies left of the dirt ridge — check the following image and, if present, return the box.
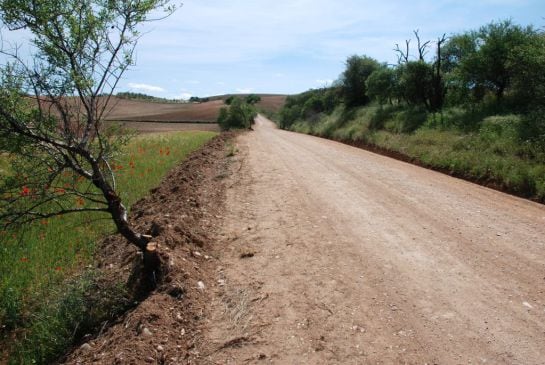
[0,131,216,363]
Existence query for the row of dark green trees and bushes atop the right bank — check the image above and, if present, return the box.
[279,20,545,140]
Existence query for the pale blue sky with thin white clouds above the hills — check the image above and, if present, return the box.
[1,0,545,98]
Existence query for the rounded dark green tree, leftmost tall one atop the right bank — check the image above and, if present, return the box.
[341,55,380,107]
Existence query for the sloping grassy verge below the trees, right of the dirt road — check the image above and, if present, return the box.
[291,105,545,202]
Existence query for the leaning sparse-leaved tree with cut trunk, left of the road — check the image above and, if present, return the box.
[0,0,174,250]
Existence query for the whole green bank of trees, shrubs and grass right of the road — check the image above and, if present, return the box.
[277,21,545,202]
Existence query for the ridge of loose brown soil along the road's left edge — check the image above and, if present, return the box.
[60,135,231,365]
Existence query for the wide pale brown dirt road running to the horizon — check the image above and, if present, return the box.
[204,117,545,364]
